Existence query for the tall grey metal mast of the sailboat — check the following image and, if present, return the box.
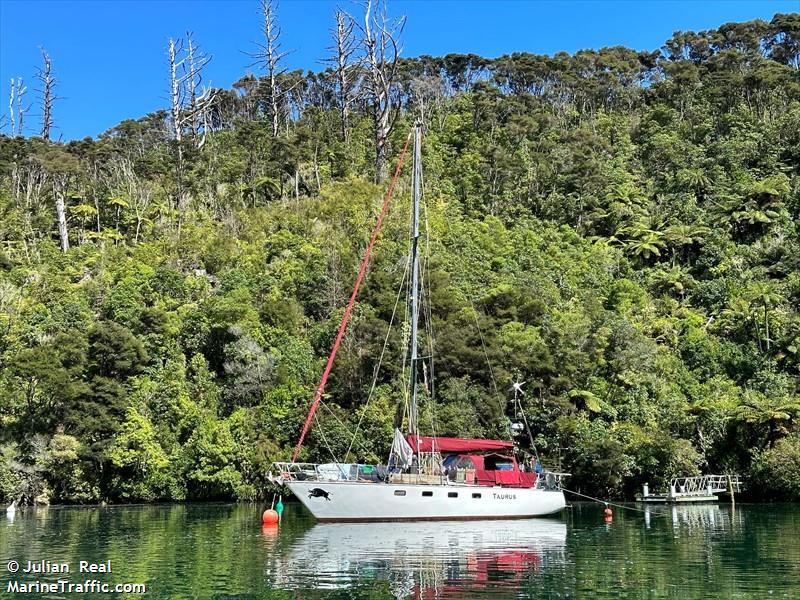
[408,121,422,440]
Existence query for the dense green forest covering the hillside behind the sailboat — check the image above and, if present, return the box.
[0,14,800,502]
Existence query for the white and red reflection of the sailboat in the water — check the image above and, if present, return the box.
[275,519,567,597]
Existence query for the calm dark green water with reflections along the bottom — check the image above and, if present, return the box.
[0,504,800,600]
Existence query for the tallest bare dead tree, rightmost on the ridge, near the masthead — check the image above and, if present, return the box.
[361,0,405,183]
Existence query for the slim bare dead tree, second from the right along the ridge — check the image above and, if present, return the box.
[325,9,362,142]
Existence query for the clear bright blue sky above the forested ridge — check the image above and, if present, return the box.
[0,0,800,140]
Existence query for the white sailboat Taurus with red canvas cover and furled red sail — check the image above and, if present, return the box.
[269,123,566,522]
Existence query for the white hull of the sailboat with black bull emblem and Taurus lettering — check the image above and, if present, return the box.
[286,481,566,521]
